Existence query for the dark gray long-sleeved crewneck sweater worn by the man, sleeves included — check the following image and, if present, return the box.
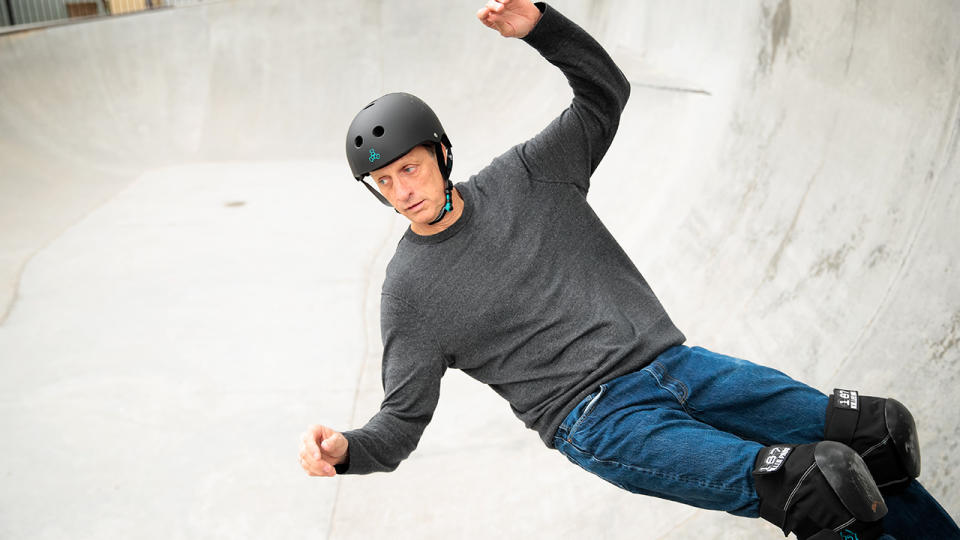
[338,4,684,474]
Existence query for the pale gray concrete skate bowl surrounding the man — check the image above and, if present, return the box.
[0,0,960,538]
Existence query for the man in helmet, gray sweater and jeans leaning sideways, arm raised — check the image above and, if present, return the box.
[300,0,956,538]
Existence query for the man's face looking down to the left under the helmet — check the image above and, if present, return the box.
[370,146,446,225]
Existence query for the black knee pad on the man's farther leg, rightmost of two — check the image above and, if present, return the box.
[824,388,920,488]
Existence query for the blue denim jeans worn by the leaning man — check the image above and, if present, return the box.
[554,346,956,538]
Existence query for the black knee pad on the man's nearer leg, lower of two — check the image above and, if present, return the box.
[753,441,887,540]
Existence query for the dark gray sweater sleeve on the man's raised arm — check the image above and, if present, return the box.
[518,3,630,195]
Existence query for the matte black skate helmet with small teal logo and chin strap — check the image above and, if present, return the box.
[346,92,453,223]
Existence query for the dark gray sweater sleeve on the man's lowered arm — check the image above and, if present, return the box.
[337,293,446,474]
